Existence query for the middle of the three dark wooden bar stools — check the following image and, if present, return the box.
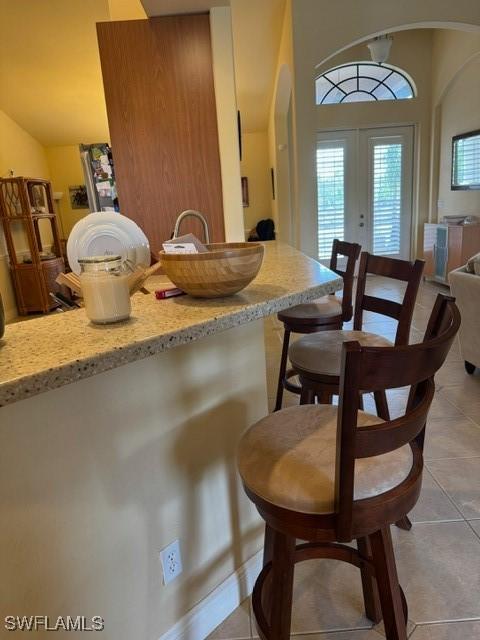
[288,251,424,420]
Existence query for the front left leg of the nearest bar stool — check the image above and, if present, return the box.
[270,531,296,640]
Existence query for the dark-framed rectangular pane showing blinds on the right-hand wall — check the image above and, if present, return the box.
[452,131,480,191]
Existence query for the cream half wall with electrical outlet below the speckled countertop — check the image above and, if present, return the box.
[0,322,267,640]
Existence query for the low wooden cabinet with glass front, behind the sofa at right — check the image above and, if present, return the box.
[423,223,480,284]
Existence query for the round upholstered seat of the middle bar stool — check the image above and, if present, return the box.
[288,330,393,378]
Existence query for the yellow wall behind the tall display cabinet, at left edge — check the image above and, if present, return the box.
[0,111,50,322]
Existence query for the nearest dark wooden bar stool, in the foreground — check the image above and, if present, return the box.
[238,295,460,640]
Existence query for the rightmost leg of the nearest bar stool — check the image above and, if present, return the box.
[369,526,407,640]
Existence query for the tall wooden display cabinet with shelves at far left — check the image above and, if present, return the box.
[0,177,65,315]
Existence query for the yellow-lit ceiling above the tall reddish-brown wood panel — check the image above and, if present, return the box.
[0,0,285,146]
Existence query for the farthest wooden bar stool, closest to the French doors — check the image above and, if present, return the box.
[274,239,361,411]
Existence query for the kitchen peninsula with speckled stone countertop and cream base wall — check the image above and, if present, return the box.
[0,243,342,640]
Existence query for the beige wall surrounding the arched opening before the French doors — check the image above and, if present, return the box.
[286,0,480,255]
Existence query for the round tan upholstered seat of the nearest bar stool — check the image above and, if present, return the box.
[238,405,412,514]
